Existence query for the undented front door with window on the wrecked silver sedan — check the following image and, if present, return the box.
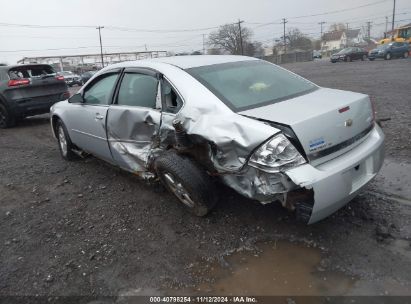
[64,69,120,162]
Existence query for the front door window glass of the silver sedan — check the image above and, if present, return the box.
[84,74,118,105]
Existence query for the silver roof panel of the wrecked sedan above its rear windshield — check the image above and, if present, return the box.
[147,55,258,69]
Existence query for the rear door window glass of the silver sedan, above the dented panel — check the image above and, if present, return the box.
[117,73,158,109]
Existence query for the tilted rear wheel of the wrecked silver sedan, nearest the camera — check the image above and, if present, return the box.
[154,151,217,216]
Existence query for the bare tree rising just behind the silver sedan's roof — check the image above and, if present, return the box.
[208,24,252,55]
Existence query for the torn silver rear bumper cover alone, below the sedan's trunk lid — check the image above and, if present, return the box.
[285,126,384,224]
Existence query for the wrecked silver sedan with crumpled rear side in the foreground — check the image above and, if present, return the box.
[51,55,384,223]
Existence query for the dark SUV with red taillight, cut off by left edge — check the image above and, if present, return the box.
[0,64,70,128]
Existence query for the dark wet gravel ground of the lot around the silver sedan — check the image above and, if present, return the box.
[0,59,411,297]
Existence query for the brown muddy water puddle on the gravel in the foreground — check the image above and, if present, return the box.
[188,242,356,296]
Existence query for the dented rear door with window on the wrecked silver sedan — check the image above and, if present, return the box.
[107,68,161,173]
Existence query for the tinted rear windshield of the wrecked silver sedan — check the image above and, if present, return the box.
[186,60,317,112]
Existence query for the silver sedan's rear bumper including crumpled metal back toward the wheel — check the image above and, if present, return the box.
[222,125,384,224]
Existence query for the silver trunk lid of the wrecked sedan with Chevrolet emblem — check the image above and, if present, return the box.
[239,88,374,165]
